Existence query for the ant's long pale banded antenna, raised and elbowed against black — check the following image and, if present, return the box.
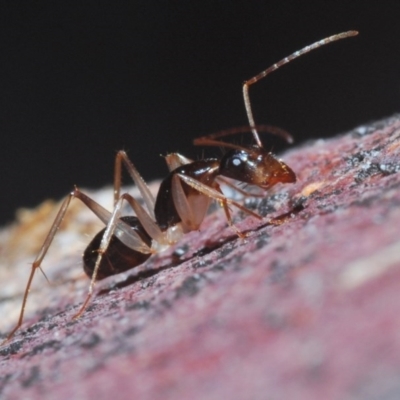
[243,31,358,147]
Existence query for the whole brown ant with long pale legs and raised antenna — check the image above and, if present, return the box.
[1,31,358,344]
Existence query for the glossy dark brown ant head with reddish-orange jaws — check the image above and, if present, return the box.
[219,146,296,189]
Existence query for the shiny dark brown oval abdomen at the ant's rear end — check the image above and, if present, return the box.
[83,216,152,280]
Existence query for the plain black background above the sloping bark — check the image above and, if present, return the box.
[0,0,400,223]
